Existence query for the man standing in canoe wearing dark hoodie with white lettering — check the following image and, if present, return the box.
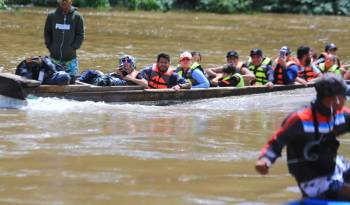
[44,0,84,83]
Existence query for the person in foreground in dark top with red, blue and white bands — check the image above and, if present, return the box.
[255,73,350,201]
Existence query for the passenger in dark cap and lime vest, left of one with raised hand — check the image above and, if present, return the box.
[247,48,274,88]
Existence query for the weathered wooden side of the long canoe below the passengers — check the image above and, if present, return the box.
[28,85,312,104]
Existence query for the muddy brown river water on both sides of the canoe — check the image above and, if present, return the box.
[0,8,350,205]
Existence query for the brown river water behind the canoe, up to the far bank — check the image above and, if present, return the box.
[0,7,350,72]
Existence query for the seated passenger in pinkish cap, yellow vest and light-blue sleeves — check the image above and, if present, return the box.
[175,51,210,88]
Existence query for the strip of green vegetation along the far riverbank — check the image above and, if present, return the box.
[4,0,350,15]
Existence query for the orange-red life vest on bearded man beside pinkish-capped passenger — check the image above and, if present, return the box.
[148,64,174,89]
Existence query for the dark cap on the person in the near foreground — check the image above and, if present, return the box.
[315,73,350,99]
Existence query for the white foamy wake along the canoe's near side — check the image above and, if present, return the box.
[22,88,314,115]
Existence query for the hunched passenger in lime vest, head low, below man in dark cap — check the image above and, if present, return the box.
[218,65,244,87]
